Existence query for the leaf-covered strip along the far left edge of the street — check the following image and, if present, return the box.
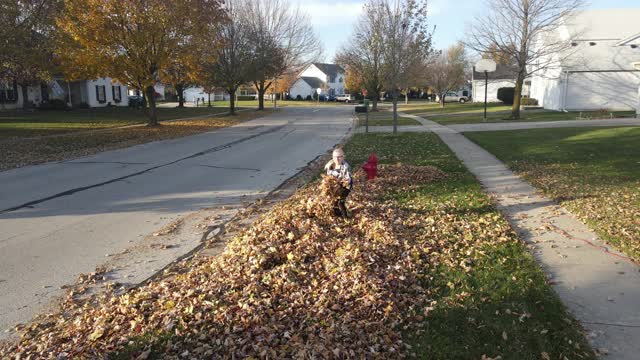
[0,112,265,171]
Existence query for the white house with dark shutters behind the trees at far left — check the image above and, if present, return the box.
[0,77,128,109]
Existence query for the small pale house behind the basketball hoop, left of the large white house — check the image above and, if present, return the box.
[471,64,530,102]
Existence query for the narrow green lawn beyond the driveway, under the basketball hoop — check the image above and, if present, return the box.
[428,107,635,125]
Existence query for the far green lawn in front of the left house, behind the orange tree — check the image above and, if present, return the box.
[0,107,227,139]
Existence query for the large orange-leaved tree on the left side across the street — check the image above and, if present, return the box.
[57,0,226,126]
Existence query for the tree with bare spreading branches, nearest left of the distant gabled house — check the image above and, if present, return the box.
[242,0,322,110]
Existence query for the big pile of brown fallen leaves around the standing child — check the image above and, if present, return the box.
[0,165,516,359]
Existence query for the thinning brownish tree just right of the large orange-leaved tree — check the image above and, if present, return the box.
[203,0,253,115]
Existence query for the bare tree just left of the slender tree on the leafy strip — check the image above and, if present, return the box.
[335,1,384,111]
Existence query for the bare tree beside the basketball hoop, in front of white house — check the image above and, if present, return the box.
[466,0,584,119]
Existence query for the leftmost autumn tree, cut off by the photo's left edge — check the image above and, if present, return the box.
[0,0,60,109]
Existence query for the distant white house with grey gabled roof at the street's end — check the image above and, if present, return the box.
[289,63,345,99]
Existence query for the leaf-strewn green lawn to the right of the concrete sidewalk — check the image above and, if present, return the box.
[465,127,640,261]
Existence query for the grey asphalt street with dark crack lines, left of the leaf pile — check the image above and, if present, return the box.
[0,106,352,337]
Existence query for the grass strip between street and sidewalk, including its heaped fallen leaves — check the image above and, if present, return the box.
[0,134,593,359]
